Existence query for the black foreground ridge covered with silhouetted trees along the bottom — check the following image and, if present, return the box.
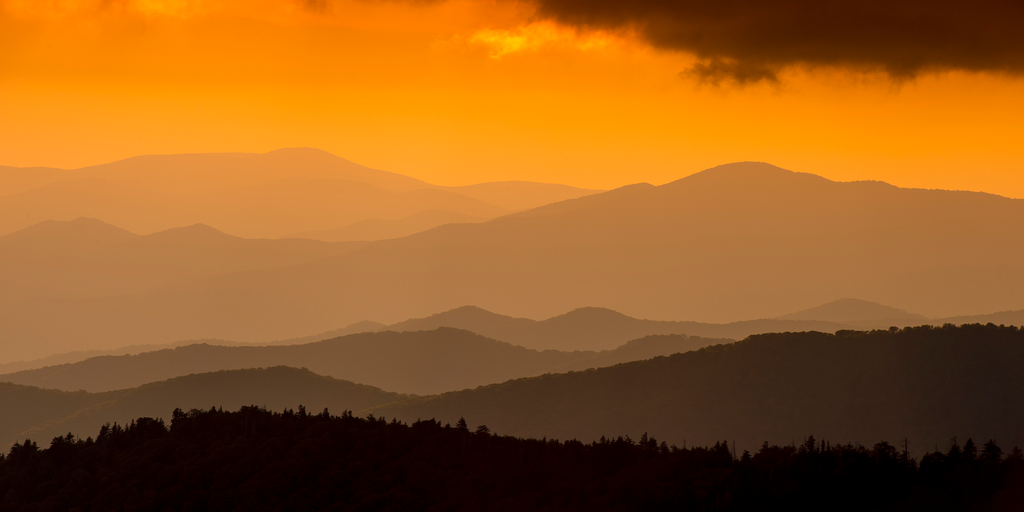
[0,407,1024,511]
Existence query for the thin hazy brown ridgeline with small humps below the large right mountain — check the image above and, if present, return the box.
[9,299,1024,374]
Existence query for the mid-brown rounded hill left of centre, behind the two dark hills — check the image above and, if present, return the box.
[0,328,732,394]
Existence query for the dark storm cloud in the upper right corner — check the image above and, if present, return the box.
[535,0,1024,83]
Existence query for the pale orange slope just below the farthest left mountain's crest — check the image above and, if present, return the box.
[0,176,509,238]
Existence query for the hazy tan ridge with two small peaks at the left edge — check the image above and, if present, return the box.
[0,217,366,303]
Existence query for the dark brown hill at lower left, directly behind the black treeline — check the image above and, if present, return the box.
[0,367,407,449]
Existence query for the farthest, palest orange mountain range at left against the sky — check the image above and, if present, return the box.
[0,148,596,241]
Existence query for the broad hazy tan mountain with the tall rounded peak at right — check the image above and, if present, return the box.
[0,163,1024,352]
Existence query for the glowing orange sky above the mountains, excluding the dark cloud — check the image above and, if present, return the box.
[0,0,1024,198]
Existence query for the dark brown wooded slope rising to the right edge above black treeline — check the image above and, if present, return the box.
[374,325,1024,454]
